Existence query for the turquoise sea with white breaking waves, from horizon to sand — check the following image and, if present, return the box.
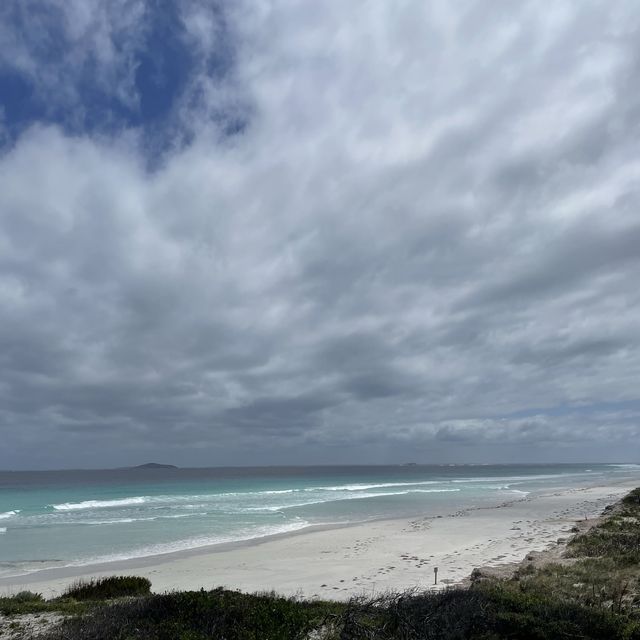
[0,464,640,577]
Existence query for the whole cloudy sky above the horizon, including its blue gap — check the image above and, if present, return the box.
[0,0,640,468]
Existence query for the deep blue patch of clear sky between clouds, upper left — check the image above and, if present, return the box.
[0,0,246,156]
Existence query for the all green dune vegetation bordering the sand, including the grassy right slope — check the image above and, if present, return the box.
[8,489,640,640]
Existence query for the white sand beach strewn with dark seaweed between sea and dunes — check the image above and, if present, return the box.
[0,480,638,599]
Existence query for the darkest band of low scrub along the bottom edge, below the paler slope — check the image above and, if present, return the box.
[33,582,640,640]
